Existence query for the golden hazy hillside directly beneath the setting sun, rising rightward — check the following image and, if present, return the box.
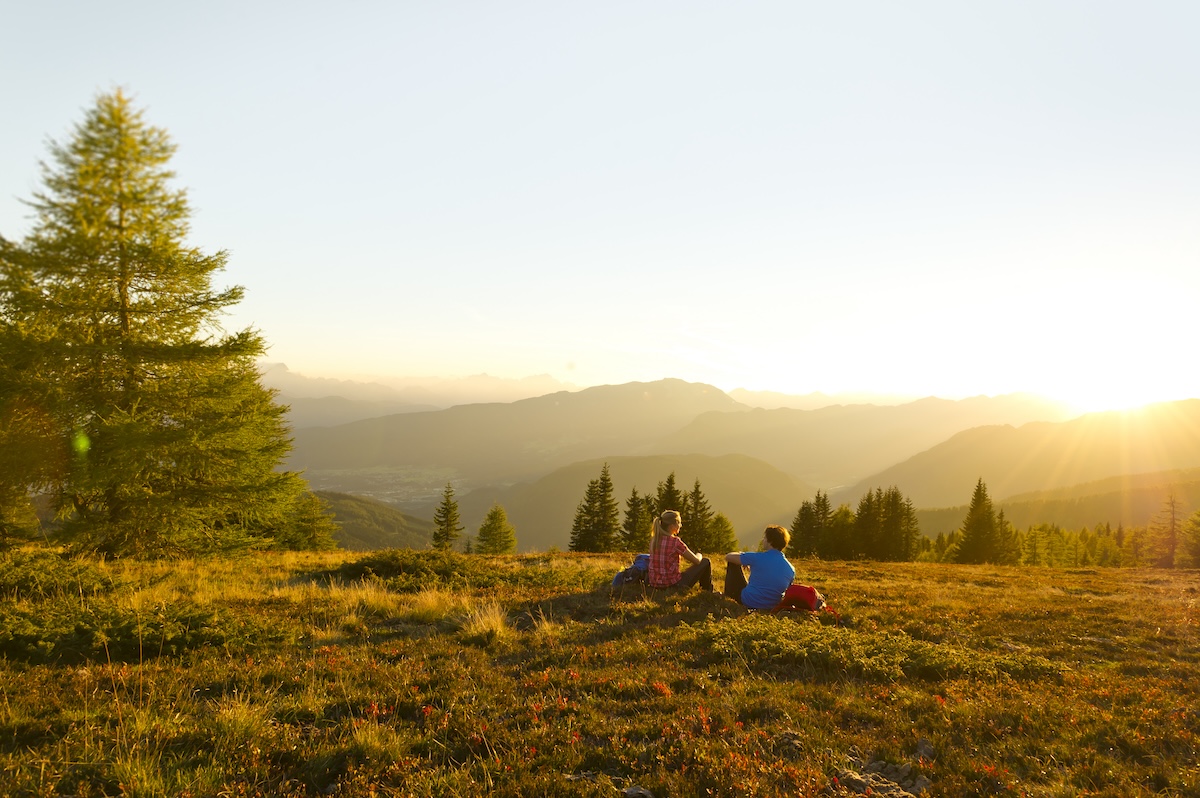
[833,400,1200,508]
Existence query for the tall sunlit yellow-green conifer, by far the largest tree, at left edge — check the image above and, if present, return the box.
[0,91,329,554]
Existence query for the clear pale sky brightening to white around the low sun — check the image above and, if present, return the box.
[0,0,1200,409]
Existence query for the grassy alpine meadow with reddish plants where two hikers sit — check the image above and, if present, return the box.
[0,551,1200,798]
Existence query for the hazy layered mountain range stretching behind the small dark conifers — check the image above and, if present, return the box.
[276,379,1200,548]
